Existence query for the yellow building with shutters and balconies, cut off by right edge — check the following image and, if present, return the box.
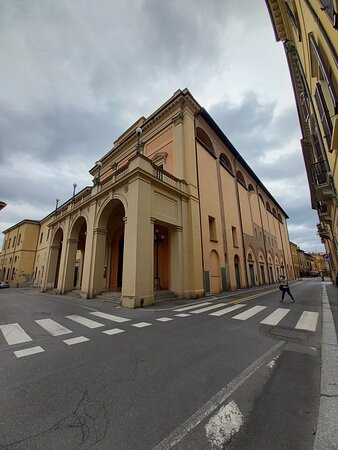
[266,0,338,279]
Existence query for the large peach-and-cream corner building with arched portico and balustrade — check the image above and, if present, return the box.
[1,89,294,307]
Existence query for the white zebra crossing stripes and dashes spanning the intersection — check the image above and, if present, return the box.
[0,302,319,358]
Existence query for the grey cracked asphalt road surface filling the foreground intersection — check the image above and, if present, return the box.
[0,279,328,450]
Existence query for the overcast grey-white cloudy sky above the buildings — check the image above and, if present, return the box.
[0,0,324,251]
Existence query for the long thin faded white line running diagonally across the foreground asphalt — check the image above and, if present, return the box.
[153,341,285,450]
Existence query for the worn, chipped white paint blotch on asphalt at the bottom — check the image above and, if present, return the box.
[205,401,243,448]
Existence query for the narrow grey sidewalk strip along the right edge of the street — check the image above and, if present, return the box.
[314,283,338,450]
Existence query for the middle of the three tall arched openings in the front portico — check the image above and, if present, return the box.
[63,216,87,292]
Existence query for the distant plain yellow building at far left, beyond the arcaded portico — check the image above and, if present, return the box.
[0,220,40,286]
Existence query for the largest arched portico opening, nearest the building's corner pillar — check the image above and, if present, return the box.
[93,199,125,295]
